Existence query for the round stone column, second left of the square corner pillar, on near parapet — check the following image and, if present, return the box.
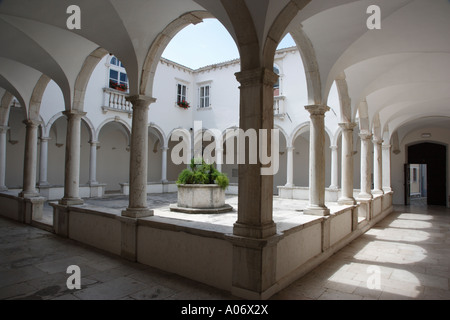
[59,110,86,205]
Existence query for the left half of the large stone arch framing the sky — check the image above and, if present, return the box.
[139,11,214,96]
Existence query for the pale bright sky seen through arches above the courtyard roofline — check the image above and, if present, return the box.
[162,19,295,70]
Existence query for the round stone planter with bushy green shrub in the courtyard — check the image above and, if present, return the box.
[170,159,233,213]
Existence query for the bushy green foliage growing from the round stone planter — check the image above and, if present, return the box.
[177,158,230,189]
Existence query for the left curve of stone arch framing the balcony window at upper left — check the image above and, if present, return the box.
[73,48,108,111]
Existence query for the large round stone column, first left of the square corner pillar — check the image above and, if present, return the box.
[122,95,156,218]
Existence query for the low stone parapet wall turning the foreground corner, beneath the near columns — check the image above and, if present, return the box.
[0,193,392,299]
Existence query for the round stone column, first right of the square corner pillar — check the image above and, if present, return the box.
[304,105,330,216]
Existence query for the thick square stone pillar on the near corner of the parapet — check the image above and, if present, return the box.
[233,68,278,239]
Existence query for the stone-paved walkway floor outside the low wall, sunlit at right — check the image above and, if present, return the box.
[0,205,450,300]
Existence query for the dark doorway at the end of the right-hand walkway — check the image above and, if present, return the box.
[408,142,447,206]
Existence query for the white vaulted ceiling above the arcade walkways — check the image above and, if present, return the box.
[0,0,450,141]
